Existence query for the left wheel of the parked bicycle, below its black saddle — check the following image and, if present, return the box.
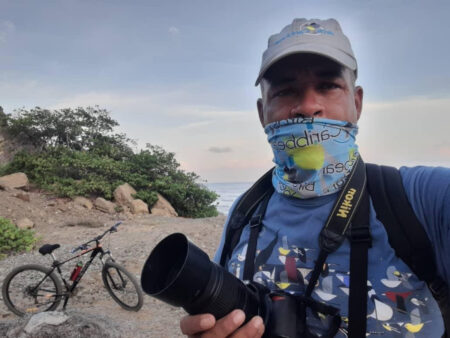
[2,264,63,316]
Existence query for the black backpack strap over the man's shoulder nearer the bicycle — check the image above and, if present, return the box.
[220,168,274,266]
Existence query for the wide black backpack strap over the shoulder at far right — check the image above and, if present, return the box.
[366,163,450,337]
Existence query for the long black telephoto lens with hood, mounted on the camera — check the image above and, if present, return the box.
[141,233,260,321]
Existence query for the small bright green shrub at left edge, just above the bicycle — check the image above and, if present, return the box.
[0,217,37,259]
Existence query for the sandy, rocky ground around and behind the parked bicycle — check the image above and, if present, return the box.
[0,190,225,337]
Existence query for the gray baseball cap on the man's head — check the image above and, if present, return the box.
[255,19,358,86]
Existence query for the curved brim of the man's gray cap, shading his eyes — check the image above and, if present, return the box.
[255,43,357,86]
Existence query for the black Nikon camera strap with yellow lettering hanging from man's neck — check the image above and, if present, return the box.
[243,156,371,337]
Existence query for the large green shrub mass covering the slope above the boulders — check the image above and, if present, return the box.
[0,107,218,217]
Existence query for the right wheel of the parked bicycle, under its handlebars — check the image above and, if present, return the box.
[102,261,144,311]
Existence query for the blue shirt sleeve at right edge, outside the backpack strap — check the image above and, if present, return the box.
[400,167,450,285]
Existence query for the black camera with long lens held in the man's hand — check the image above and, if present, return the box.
[141,233,340,338]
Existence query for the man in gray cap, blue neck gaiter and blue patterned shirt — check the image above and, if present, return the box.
[180,19,450,338]
